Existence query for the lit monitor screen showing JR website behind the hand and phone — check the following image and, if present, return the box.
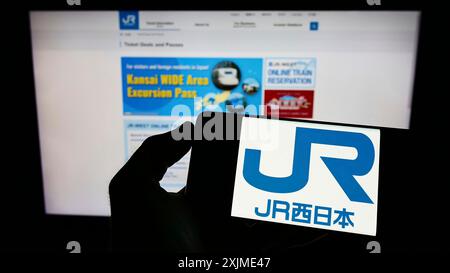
[30,11,420,215]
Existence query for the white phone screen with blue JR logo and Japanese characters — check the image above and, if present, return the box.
[232,118,380,235]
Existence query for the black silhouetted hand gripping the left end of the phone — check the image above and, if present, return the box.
[109,122,204,252]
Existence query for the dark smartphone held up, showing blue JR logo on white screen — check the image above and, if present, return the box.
[186,112,408,251]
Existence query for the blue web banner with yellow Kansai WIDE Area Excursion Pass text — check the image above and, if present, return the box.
[122,57,262,116]
